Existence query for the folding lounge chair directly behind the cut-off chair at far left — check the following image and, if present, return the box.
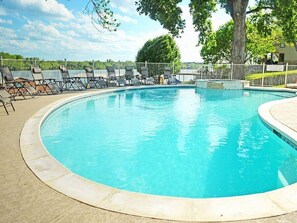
[0,66,38,99]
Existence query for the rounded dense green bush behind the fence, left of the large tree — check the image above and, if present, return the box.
[136,34,181,72]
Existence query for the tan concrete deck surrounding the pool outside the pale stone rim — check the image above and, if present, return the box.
[0,86,297,222]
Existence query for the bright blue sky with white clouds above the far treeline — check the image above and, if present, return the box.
[0,0,230,62]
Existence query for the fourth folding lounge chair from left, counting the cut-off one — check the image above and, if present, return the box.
[59,65,86,91]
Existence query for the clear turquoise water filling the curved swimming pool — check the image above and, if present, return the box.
[41,88,297,198]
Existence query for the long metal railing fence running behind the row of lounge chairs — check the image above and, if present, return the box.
[0,58,297,87]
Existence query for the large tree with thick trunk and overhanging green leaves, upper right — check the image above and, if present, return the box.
[136,0,297,79]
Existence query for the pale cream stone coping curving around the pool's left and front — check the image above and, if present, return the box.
[20,86,297,221]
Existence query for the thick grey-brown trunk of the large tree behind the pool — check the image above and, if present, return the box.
[228,0,249,80]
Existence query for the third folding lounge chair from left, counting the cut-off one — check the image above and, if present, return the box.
[31,66,61,94]
